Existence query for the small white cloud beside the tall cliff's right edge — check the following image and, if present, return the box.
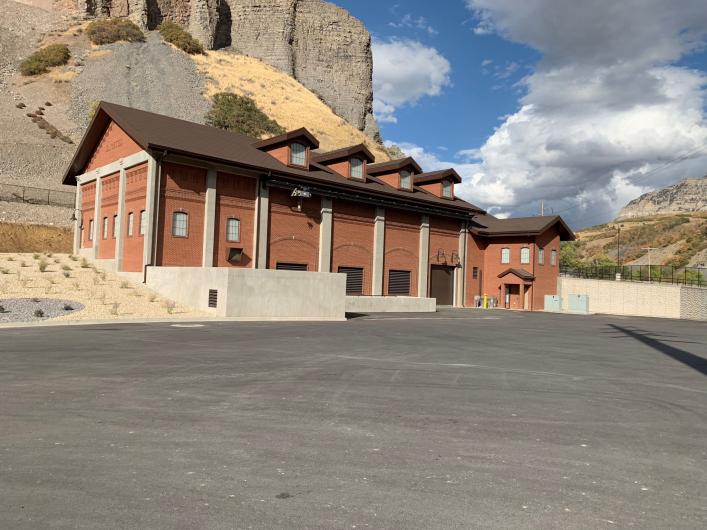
[373,38,452,123]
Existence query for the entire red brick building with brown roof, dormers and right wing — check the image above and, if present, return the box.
[63,102,574,310]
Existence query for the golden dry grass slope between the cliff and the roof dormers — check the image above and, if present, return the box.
[194,50,390,162]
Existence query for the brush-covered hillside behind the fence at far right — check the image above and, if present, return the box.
[562,213,707,267]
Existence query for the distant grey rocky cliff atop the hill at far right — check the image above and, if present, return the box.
[616,176,707,221]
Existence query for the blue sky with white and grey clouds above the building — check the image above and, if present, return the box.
[333,0,707,228]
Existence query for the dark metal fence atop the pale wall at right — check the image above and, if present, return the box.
[560,265,707,287]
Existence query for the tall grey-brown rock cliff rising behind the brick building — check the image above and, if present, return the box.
[69,0,380,139]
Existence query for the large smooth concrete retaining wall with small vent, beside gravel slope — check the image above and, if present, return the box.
[147,267,346,320]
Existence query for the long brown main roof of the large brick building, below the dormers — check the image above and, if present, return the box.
[63,102,484,216]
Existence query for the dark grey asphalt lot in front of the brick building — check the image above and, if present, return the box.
[0,311,707,529]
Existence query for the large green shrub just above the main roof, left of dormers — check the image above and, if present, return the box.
[206,92,285,138]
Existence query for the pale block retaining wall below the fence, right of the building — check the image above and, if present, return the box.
[557,277,707,320]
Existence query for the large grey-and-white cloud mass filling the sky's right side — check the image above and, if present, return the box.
[456,0,707,225]
